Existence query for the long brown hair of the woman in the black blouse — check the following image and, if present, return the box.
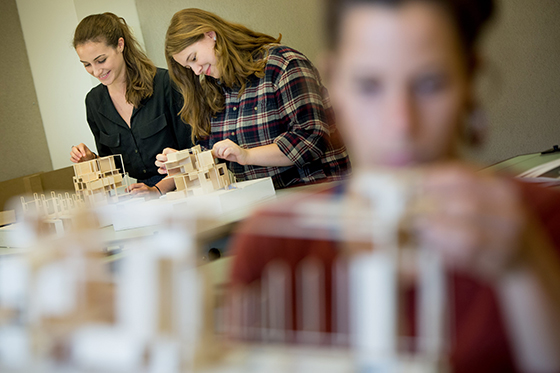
[73,13,157,107]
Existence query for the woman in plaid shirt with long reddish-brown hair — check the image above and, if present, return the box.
[156,9,349,188]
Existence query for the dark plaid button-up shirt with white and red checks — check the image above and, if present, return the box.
[200,45,350,188]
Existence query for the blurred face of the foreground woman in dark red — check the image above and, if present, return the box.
[330,2,471,167]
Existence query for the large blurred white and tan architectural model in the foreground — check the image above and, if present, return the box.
[0,171,448,373]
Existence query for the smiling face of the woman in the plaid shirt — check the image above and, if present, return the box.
[173,31,221,79]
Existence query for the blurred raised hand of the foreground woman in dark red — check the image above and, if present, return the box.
[413,164,529,278]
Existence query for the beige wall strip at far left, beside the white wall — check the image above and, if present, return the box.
[0,0,52,181]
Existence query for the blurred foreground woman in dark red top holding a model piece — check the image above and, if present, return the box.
[232,0,560,372]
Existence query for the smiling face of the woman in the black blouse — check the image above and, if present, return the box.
[76,38,126,86]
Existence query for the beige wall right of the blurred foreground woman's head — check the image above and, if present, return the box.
[471,0,560,162]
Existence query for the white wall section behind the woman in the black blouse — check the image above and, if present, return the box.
[17,0,143,169]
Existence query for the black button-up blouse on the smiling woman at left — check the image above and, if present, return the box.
[86,68,193,180]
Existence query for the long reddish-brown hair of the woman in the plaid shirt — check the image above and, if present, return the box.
[165,8,282,141]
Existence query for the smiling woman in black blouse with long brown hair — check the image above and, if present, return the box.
[70,13,192,195]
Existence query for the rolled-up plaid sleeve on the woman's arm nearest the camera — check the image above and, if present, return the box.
[274,59,329,168]
